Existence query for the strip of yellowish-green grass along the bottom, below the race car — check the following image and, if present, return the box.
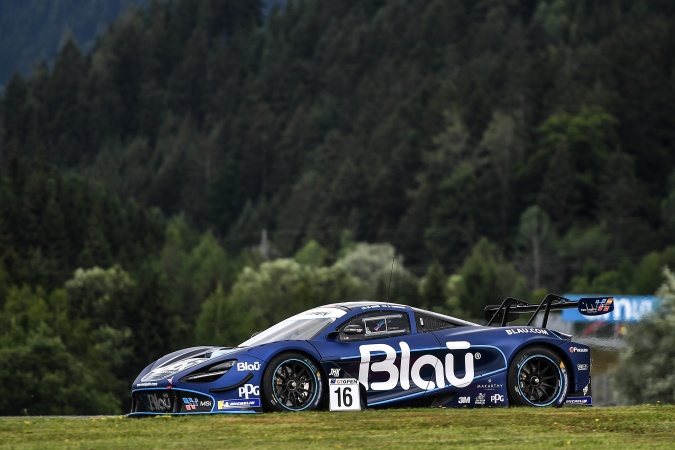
[0,405,675,450]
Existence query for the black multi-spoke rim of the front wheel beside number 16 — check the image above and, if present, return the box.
[272,359,318,411]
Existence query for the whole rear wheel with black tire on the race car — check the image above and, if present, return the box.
[507,346,568,407]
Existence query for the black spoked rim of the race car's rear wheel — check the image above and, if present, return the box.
[518,355,562,406]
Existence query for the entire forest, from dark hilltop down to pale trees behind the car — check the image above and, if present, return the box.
[0,0,675,414]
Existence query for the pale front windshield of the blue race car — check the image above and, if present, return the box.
[239,308,346,347]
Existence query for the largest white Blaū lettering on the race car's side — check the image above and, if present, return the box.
[360,341,474,391]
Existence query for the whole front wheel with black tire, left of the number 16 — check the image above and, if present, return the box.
[262,353,323,411]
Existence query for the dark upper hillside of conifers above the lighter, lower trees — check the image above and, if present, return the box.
[2,0,675,270]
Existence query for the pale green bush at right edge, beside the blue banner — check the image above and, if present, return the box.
[616,267,675,404]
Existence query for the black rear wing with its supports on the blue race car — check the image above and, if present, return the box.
[485,294,614,328]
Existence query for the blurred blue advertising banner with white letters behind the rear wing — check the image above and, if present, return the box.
[562,294,661,322]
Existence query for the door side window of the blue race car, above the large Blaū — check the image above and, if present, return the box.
[340,311,410,342]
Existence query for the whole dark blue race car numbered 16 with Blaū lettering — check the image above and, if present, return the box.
[130,294,614,416]
